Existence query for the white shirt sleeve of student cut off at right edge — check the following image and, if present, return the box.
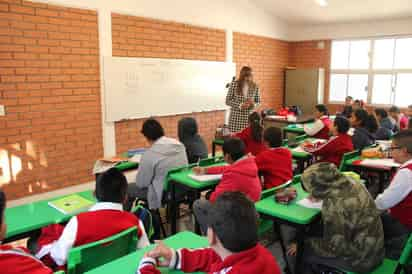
[375,159,412,210]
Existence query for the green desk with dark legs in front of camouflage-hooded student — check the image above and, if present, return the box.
[255,183,320,273]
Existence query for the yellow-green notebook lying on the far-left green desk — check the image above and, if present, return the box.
[48,194,95,215]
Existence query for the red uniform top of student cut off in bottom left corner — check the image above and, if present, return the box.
[0,245,53,274]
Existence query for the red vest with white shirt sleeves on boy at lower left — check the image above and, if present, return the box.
[36,202,150,266]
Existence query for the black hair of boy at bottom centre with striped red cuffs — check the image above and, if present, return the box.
[207,192,258,252]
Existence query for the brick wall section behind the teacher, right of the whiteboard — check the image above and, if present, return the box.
[233,32,288,109]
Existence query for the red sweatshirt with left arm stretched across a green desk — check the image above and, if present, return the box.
[207,157,262,202]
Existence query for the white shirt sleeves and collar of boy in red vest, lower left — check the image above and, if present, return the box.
[36,202,150,266]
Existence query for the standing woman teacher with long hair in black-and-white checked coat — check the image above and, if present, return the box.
[226,66,260,133]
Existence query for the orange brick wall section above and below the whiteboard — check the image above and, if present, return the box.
[112,14,225,153]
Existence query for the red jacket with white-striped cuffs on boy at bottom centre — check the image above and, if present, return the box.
[136,244,281,274]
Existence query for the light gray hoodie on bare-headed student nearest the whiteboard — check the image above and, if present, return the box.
[136,136,188,209]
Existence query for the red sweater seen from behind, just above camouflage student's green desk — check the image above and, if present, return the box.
[255,147,293,189]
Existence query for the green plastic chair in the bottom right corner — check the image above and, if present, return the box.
[346,234,412,274]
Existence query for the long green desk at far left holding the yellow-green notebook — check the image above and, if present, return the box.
[5,190,95,242]
